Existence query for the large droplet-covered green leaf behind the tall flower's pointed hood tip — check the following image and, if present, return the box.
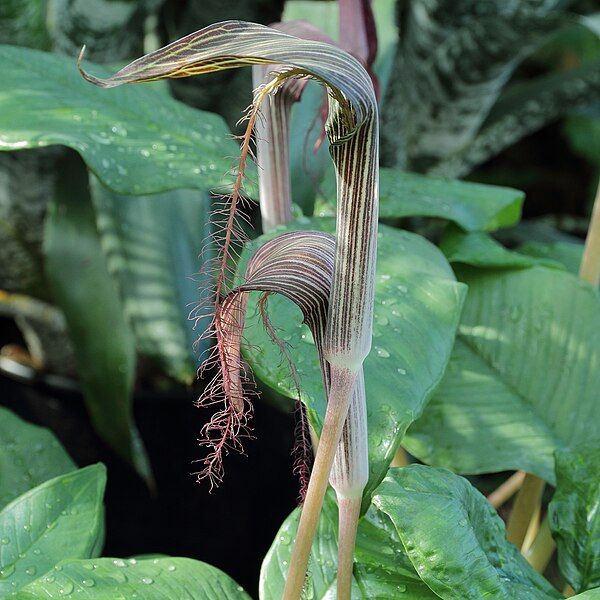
[0,46,238,194]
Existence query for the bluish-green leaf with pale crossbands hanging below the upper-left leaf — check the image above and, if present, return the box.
[91,178,210,384]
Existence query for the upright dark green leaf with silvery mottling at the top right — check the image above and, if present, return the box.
[382,0,562,170]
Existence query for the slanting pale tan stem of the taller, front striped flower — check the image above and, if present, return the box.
[282,366,357,600]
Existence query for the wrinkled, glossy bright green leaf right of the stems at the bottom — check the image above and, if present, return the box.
[373,465,562,600]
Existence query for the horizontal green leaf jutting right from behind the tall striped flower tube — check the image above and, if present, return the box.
[321,168,525,231]
